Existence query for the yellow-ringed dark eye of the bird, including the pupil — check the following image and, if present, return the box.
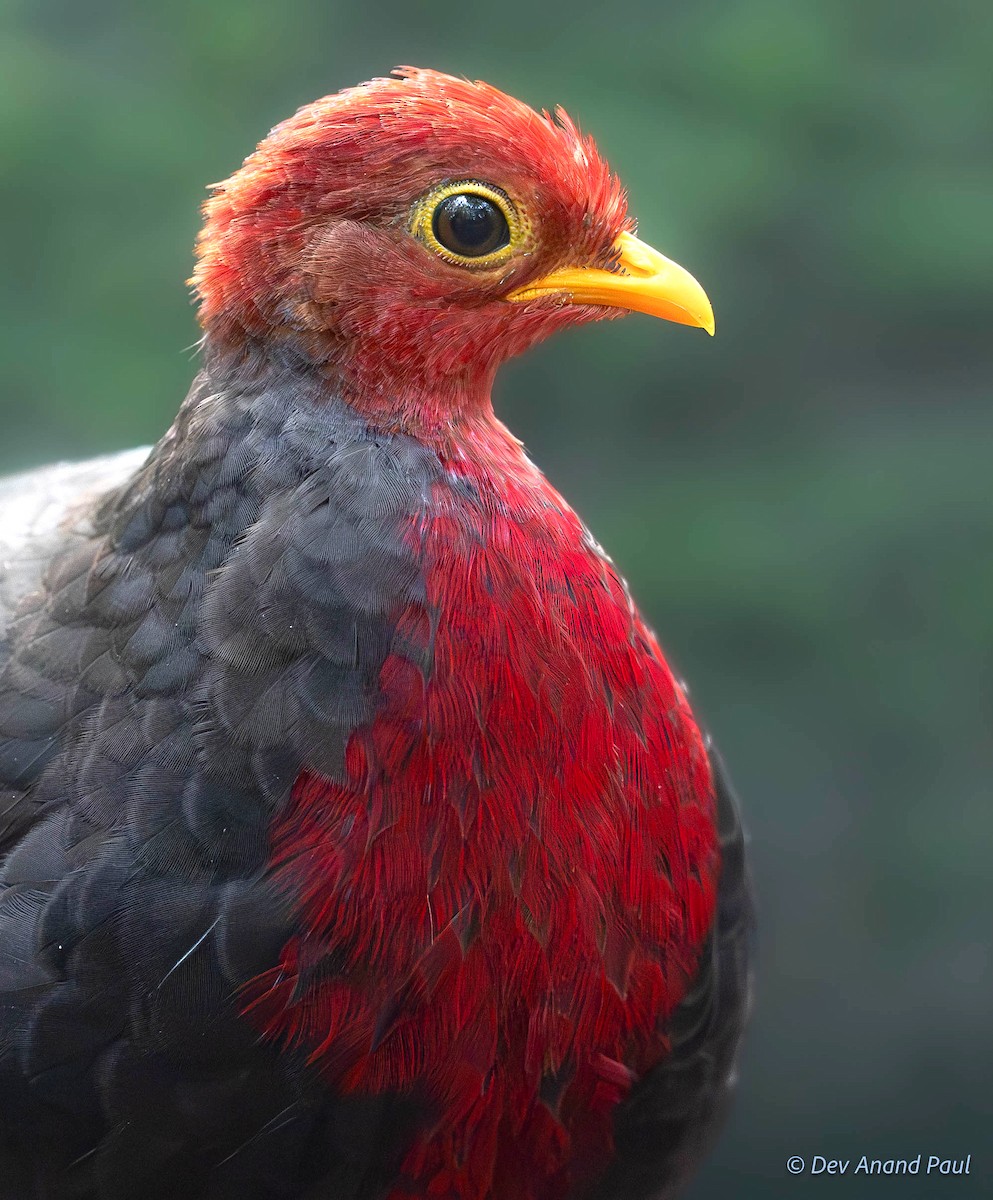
[410,179,529,270]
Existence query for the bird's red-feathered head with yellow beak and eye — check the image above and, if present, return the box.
[192,67,714,428]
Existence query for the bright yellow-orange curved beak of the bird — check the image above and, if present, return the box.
[507,233,714,335]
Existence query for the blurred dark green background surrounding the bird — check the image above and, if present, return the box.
[0,0,993,1200]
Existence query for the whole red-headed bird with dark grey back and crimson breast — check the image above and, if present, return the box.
[0,67,753,1200]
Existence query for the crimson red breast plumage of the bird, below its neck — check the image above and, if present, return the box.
[249,422,718,1200]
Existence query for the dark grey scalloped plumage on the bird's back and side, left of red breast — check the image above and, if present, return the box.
[0,355,437,1200]
